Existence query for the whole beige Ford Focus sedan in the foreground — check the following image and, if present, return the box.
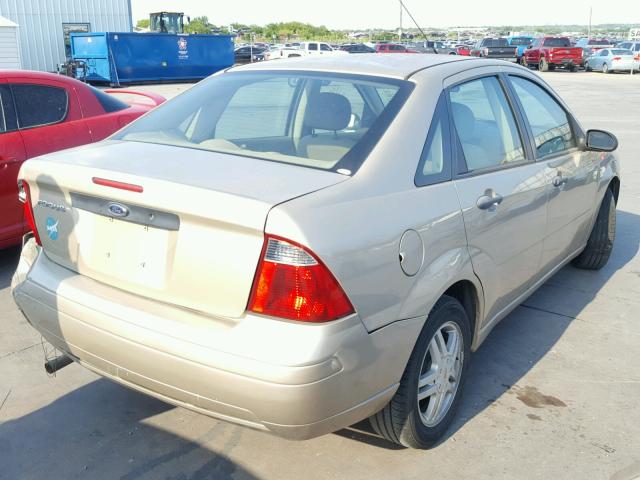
[13,54,620,448]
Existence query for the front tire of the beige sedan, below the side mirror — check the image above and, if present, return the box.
[572,189,616,270]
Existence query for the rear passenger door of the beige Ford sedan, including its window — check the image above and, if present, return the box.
[448,72,547,321]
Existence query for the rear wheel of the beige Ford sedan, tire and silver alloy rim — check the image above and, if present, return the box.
[369,295,471,449]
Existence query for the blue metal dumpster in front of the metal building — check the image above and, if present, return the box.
[71,32,234,85]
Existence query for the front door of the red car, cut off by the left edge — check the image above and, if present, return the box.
[0,80,26,244]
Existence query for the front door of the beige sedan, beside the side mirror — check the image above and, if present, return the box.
[509,75,600,271]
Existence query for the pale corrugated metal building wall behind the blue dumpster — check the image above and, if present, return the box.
[0,0,133,72]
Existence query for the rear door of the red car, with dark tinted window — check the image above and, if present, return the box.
[8,79,91,158]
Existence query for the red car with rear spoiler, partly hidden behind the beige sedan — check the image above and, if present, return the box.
[0,71,165,248]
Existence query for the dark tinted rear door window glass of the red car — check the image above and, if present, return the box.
[11,85,69,128]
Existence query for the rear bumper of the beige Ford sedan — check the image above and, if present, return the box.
[13,242,424,439]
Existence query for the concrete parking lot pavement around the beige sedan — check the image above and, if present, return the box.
[0,71,640,480]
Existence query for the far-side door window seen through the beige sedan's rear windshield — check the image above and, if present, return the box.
[215,78,295,139]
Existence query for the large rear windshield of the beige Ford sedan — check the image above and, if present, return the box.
[114,71,412,175]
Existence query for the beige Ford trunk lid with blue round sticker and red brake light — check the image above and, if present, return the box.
[20,142,349,317]
